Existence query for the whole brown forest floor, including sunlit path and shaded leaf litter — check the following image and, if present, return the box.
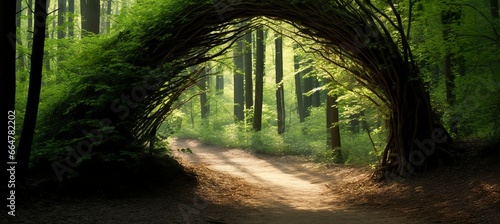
[4,139,500,224]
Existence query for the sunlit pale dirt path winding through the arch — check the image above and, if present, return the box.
[171,139,422,224]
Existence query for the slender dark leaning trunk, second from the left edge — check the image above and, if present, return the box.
[16,0,47,184]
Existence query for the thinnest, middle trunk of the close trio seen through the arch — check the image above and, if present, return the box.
[243,26,253,110]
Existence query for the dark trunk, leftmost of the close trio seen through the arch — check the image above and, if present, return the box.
[233,37,245,121]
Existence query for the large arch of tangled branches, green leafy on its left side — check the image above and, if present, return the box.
[37,0,451,182]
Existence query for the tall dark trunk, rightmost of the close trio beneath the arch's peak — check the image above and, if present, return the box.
[253,28,265,131]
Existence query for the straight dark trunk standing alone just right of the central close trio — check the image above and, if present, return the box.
[274,34,285,134]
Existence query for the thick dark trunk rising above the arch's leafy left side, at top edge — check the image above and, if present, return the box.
[80,0,101,34]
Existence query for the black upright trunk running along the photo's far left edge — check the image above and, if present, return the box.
[0,1,17,205]
